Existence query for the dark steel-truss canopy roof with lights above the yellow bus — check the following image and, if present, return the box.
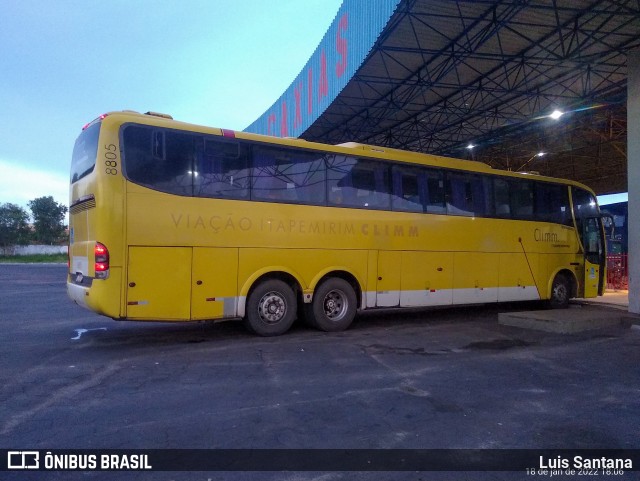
[249,0,640,193]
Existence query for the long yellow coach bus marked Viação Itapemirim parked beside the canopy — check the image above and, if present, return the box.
[67,111,606,336]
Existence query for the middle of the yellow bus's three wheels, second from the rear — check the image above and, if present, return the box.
[305,277,357,332]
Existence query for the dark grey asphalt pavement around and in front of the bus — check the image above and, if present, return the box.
[0,265,640,481]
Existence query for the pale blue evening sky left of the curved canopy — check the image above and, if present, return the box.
[0,0,342,207]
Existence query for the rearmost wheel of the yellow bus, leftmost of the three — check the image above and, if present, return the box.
[245,279,297,336]
